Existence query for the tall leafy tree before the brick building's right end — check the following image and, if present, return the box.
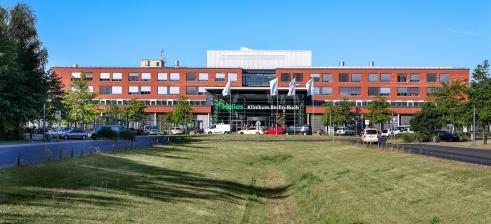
[430,80,471,131]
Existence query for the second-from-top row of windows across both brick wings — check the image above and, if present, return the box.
[89,86,437,96]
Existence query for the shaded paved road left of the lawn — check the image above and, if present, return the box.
[0,136,168,168]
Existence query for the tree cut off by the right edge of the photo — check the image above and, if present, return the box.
[470,60,491,144]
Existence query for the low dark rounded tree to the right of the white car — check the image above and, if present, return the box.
[410,104,446,134]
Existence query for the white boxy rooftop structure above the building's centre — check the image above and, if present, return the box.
[206,47,312,69]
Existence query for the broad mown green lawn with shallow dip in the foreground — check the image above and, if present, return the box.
[0,135,491,223]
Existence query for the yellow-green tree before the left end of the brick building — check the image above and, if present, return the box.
[63,74,99,128]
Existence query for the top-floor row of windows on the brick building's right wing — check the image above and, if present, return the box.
[280,73,449,83]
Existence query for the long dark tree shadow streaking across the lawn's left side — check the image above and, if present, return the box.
[0,147,290,222]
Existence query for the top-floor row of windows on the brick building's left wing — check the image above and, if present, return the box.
[72,72,237,82]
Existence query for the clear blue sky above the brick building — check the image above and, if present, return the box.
[0,0,491,68]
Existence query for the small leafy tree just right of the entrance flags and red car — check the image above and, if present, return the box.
[321,100,356,126]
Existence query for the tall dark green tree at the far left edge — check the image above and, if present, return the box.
[0,4,48,139]
